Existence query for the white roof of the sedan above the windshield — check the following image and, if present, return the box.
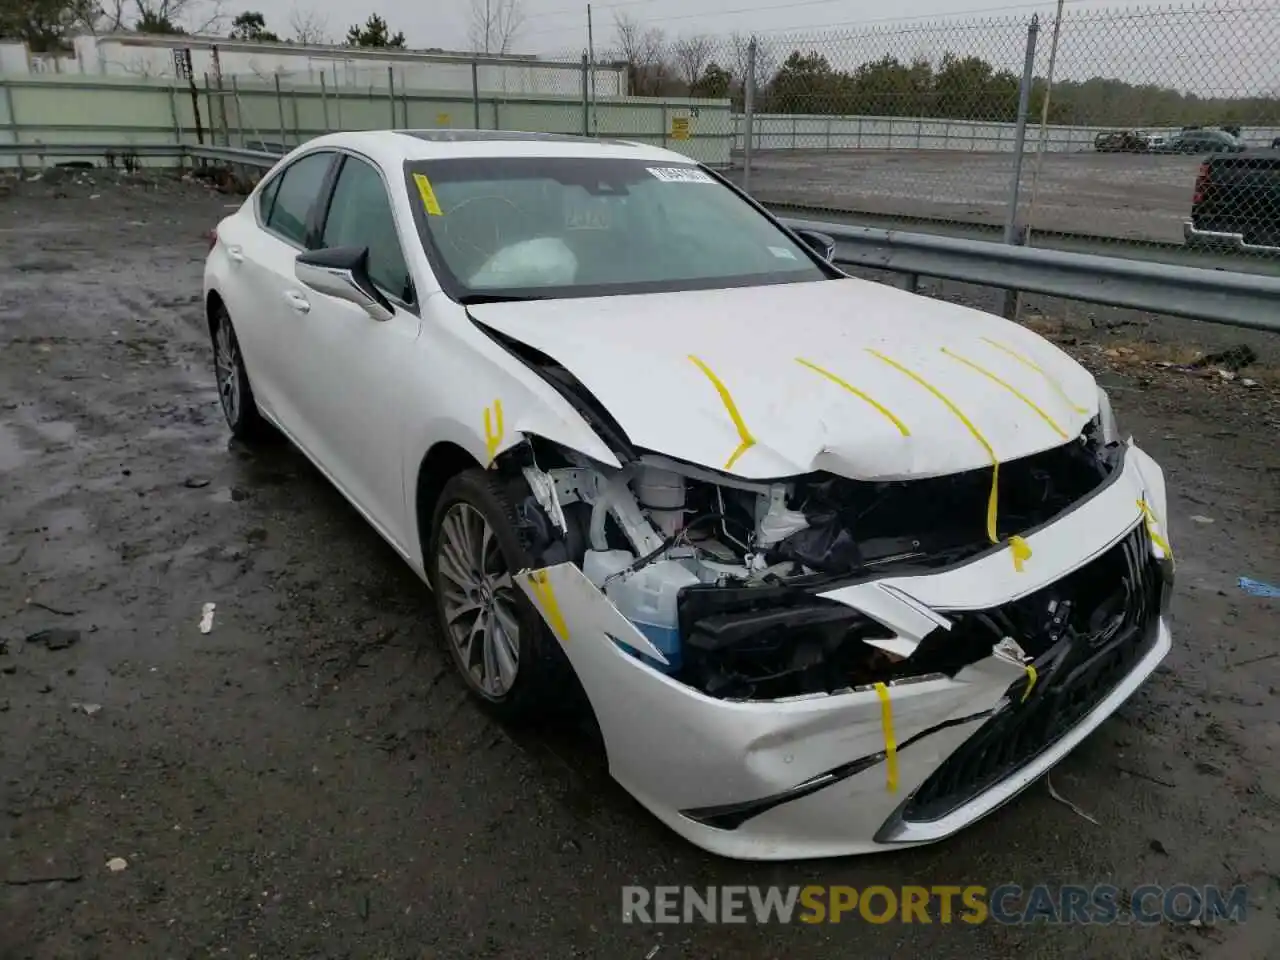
[293,129,692,166]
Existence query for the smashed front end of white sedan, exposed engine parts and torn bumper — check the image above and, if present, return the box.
[495,430,1172,859]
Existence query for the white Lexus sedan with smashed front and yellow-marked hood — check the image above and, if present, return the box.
[205,131,1172,859]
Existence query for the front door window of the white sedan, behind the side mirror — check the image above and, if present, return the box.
[321,156,413,303]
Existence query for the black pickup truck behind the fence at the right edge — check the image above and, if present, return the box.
[1183,148,1280,249]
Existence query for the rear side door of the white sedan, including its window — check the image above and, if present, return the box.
[227,150,338,437]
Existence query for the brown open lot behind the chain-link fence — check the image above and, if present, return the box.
[735,150,1201,243]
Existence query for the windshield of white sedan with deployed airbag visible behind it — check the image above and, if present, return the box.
[408,157,831,300]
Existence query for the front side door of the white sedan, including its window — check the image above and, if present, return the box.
[286,154,420,547]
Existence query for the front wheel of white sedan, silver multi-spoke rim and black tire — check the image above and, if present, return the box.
[428,468,575,721]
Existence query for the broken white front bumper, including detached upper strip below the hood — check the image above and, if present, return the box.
[520,447,1171,860]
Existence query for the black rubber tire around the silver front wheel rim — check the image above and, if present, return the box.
[424,468,584,722]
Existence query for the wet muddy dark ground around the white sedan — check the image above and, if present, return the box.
[0,177,1280,960]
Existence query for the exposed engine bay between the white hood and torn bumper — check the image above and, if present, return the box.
[495,422,1123,699]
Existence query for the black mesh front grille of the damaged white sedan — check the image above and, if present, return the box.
[902,525,1164,822]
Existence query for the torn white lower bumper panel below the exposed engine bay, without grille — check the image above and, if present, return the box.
[517,563,1169,859]
